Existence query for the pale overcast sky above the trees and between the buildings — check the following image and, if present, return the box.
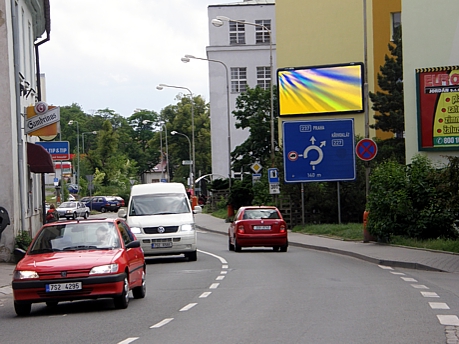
[39,0,227,117]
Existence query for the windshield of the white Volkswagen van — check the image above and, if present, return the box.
[129,193,190,216]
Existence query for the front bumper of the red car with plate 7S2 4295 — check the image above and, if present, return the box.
[12,273,125,303]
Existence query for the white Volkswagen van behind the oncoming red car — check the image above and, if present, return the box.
[118,183,202,261]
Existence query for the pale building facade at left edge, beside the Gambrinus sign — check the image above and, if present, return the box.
[0,0,50,261]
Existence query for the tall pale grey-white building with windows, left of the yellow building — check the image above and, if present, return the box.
[206,0,276,178]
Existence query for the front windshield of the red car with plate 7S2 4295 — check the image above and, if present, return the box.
[29,222,121,254]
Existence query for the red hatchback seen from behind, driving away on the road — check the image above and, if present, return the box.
[228,206,288,252]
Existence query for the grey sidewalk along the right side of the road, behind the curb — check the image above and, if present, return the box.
[195,214,459,273]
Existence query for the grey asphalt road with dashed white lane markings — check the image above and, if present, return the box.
[0,216,459,344]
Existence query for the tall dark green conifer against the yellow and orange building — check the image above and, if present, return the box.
[369,26,405,138]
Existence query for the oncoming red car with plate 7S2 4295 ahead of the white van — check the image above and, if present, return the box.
[12,219,146,316]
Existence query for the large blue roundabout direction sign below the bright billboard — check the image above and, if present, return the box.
[282,118,356,182]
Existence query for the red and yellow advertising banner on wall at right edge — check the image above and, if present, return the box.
[416,66,459,150]
